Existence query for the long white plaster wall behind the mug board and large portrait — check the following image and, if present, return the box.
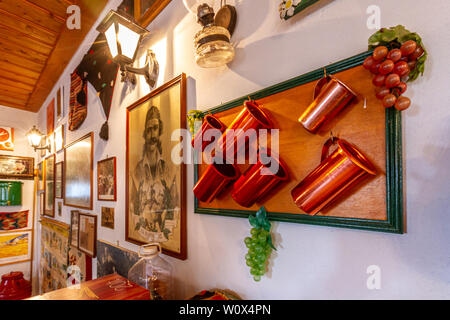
[34,0,450,299]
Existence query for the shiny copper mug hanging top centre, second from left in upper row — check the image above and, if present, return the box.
[217,101,273,159]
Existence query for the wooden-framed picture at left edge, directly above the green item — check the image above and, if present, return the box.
[0,155,34,180]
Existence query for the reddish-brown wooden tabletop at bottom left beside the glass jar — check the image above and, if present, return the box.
[27,274,150,300]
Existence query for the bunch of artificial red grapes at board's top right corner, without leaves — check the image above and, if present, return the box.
[363,40,424,111]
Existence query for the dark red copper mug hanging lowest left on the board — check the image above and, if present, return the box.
[194,157,241,202]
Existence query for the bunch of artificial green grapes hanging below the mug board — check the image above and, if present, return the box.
[244,224,272,281]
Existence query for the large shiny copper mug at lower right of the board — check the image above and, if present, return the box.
[291,138,376,215]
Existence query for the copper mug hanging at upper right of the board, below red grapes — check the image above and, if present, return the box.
[298,75,357,133]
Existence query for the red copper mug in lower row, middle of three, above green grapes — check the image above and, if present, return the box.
[231,149,289,207]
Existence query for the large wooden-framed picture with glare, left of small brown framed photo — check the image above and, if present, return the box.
[63,132,94,210]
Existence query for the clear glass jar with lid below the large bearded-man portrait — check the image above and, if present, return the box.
[128,243,172,300]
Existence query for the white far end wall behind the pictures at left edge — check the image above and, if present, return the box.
[0,106,37,280]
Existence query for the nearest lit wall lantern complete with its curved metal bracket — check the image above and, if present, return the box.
[97,10,159,87]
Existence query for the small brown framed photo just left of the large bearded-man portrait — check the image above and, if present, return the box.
[97,157,117,201]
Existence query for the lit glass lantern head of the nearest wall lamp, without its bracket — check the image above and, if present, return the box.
[97,10,148,64]
